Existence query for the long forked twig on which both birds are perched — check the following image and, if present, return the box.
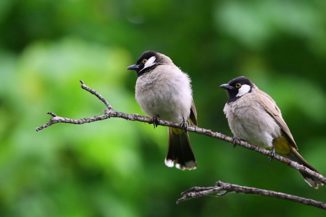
[36,81,326,184]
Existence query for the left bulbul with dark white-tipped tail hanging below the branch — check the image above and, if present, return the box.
[128,51,197,170]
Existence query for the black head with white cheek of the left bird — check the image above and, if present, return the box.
[128,51,170,76]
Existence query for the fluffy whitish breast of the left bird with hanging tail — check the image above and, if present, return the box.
[136,65,192,122]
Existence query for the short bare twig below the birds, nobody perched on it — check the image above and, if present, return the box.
[177,181,326,209]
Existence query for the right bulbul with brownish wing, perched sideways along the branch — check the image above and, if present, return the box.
[220,76,323,189]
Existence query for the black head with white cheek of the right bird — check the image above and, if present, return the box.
[220,76,254,102]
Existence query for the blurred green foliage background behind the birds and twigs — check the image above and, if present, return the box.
[0,0,326,217]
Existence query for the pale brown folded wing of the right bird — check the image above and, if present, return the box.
[256,88,298,149]
